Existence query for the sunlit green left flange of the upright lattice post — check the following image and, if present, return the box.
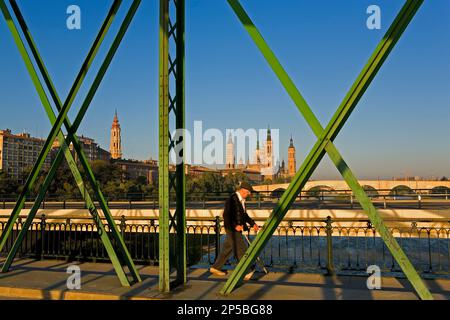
[158,0,170,293]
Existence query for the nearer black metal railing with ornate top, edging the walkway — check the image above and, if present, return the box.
[0,215,450,277]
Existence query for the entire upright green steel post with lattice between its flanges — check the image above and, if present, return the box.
[159,0,187,293]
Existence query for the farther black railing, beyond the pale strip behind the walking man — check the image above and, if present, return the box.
[0,188,450,210]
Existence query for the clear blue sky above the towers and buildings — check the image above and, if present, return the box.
[0,0,450,178]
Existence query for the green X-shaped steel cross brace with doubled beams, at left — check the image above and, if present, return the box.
[0,0,141,286]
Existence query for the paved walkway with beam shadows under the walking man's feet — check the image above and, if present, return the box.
[0,259,450,300]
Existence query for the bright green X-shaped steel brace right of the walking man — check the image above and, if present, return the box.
[221,0,433,299]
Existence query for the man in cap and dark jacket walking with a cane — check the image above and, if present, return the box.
[209,182,259,280]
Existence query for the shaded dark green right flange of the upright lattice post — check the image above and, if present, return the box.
[175,0,187,284]
